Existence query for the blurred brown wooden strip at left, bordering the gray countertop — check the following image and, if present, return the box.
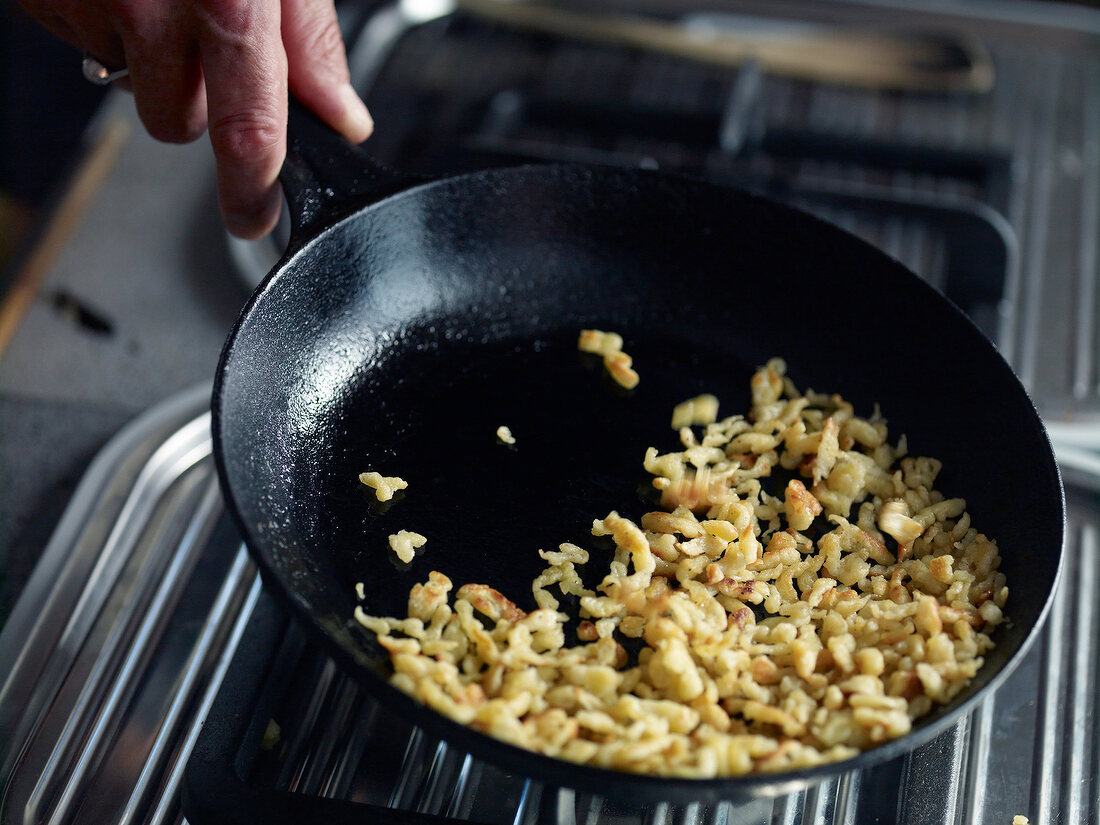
[0,117,130,355]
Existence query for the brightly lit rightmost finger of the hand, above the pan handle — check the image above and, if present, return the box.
[283,0,374,143]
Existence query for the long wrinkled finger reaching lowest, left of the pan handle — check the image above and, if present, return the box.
[196,0,287,238]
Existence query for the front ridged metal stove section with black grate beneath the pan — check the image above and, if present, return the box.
[0,376,1100,825]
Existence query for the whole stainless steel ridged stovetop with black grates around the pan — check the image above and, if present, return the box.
[0,4,1100,825]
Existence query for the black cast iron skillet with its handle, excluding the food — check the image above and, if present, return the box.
[213,103,1064,801]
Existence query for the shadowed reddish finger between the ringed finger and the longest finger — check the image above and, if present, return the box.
[116,3,207,143]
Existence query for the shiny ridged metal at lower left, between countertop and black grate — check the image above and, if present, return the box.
[0,387,259,823]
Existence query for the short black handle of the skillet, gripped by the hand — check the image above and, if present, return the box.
[279,96,428,250]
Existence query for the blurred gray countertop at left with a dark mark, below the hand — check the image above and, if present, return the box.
[0,92,249,622]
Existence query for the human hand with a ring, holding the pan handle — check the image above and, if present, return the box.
[20,0,374,238]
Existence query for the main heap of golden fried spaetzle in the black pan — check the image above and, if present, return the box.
[356,360,1008,778]
